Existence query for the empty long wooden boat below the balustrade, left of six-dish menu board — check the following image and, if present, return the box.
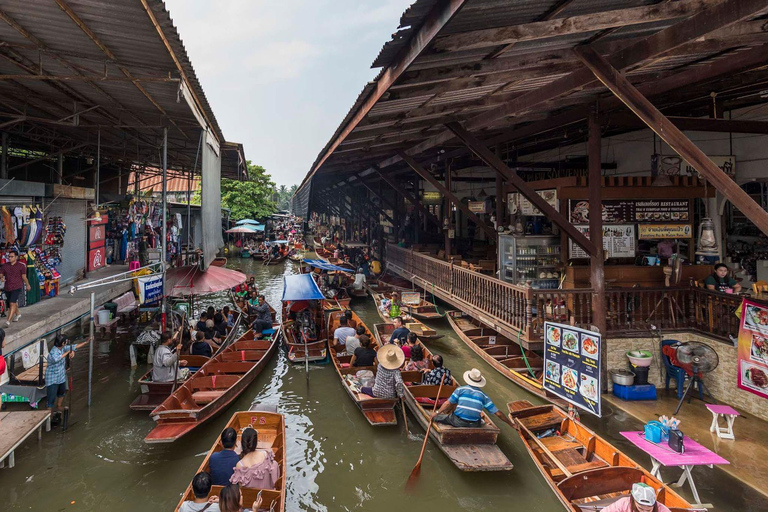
[446,311,567,407]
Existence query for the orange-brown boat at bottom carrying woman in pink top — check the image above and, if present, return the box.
[176,410,286,512]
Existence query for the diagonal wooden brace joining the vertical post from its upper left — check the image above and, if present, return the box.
[444,123,595,256]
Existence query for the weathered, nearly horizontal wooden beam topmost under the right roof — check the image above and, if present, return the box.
[433,0,720,53]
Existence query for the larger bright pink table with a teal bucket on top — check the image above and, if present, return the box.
[621,432,730,508]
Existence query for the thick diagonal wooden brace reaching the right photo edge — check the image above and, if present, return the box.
[575,46,768,235]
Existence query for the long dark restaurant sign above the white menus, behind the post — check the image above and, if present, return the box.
[569,199,690,224]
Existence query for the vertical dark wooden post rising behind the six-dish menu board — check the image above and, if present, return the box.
[587,109,608,391]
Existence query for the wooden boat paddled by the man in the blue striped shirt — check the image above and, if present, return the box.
[401,372,514,471]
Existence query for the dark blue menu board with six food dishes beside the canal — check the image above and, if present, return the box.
[544,322,602,417]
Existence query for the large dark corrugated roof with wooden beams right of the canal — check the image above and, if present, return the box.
[294,0,768,195]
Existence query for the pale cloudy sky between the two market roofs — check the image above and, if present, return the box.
[165,0,412,186]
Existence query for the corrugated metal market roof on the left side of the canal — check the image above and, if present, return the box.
[0,0,246,178]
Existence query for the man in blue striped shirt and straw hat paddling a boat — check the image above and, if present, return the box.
[435,368,514,428]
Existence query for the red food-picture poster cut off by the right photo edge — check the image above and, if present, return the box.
[737,299,768,398]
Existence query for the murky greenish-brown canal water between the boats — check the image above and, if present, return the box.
[0,254,768,512]
